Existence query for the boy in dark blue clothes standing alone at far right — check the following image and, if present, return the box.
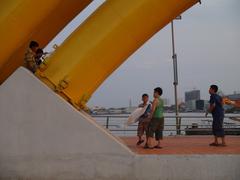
[206,85,226,146]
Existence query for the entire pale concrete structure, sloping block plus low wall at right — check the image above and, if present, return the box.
[0,68,240,180]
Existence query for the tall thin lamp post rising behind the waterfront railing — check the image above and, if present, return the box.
[171,16,181,135]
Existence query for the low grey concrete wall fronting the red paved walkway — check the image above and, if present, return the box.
[134,155,240,180]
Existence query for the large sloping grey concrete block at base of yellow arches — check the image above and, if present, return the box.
[0,68,133,179]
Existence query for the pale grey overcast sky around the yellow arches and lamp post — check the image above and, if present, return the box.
[46,0,240,107]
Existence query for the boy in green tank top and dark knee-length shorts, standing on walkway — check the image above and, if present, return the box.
[144,87,164,149]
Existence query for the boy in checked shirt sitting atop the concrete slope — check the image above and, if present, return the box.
[24,41,39,73]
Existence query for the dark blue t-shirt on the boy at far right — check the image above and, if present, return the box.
[209,94,224,117]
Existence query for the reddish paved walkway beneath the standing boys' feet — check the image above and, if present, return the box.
[122,136,240,155]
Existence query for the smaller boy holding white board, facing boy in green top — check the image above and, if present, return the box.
[137,94,151,145]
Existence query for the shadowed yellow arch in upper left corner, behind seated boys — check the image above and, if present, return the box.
[0,0,92,84]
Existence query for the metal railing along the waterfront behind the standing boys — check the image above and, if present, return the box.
[92,115,240,135]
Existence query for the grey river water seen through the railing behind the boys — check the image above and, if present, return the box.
[95,113,240,136]
